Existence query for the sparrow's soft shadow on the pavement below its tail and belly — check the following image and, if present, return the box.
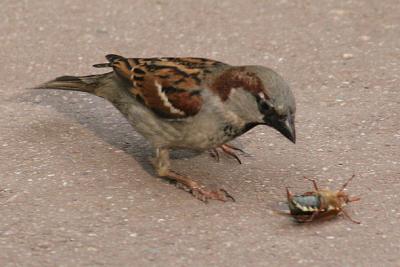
[15,89,200,175]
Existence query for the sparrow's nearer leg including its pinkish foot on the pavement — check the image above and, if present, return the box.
[154,148,235,202]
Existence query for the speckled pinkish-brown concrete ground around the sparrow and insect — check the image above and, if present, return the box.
[0,0,400,266]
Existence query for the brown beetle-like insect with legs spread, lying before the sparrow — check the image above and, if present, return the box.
[286,175,360,224]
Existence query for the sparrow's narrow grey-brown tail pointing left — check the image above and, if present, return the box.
[34,73,111,94]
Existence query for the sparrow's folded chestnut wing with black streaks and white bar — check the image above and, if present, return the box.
[94,55,225,119]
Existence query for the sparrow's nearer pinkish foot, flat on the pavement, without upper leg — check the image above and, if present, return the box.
[163,171,235,202]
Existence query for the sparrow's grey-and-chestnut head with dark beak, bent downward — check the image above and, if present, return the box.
[214,66,296,143]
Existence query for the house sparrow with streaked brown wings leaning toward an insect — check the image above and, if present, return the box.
[36,55,296,201]
